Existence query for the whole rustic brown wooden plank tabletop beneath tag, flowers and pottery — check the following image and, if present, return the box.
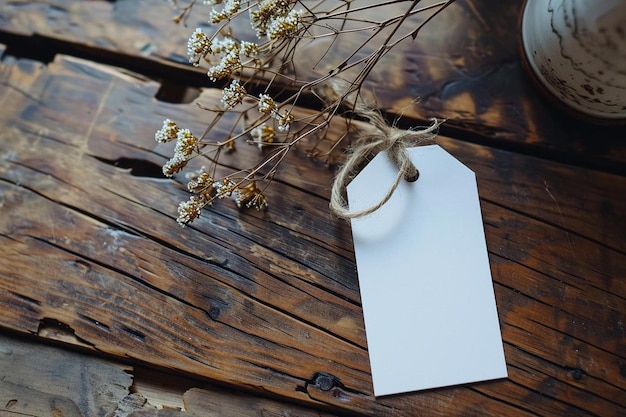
[0,0,626,416]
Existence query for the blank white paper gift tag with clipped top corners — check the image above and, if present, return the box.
[347,145,507,396]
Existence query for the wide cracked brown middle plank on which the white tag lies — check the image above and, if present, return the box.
[0,50,626,416]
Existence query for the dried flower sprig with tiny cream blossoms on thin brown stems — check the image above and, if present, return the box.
[155,0,453,225]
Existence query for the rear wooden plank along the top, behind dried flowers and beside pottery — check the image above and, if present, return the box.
[0,0,626,174]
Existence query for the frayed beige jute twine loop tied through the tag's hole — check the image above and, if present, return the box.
[330,108,441,219]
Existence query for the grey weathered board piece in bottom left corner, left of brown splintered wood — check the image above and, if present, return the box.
[0,334,132,417]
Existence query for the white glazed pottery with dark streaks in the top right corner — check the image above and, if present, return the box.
[520,0,626,123]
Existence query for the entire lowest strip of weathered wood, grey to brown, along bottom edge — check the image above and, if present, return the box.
[0,332,342,417]
